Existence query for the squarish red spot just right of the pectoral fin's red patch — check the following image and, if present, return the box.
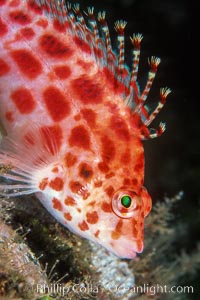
[69,125,90,150]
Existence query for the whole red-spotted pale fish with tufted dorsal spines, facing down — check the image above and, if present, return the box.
[0,0,170,258]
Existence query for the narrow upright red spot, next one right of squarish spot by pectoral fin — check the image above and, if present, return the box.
[101,135,115,163]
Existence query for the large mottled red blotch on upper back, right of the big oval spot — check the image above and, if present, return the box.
[72,75,103,104]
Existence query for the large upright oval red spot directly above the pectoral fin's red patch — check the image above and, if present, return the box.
[43,86,70,122]
